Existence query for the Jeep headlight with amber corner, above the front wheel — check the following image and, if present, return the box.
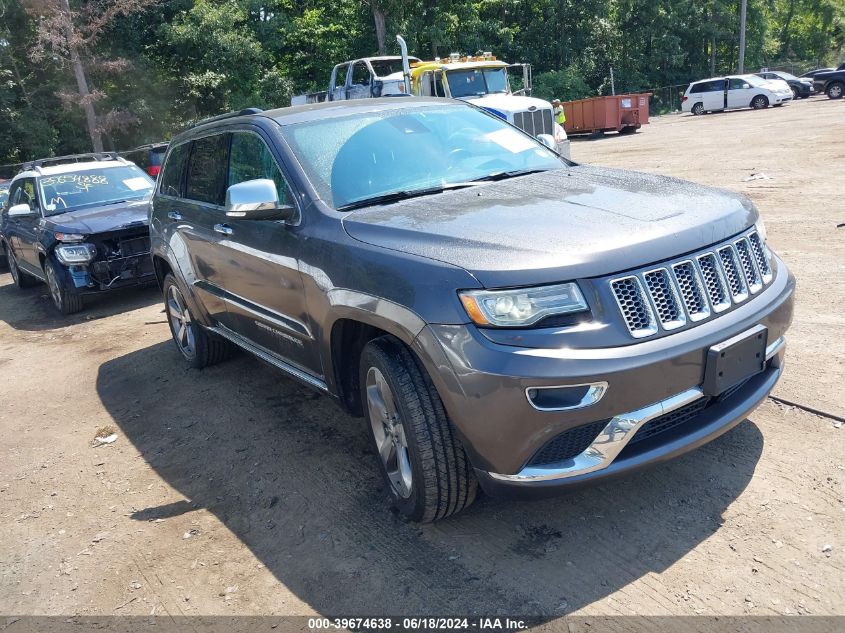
[459,283,588,327]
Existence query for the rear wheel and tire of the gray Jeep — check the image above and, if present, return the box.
[163,273,234,369]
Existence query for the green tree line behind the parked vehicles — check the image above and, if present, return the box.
[0,0,845,163]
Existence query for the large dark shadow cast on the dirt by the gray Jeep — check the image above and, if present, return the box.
[97,341,763,619]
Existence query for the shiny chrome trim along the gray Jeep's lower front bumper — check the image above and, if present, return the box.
[488,336,786,482]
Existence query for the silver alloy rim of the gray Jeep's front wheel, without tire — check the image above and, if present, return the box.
[366,367,413,499]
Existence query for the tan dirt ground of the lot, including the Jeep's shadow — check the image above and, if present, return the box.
[0,98,845,620]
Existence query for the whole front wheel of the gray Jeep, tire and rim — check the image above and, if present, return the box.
[359,336,478,523]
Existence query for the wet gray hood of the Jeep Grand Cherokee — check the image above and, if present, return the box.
[343,165,757,288]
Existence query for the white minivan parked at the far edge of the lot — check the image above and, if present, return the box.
[681,75,792,114]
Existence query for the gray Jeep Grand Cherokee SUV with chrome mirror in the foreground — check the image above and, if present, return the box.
[150,98,794,521]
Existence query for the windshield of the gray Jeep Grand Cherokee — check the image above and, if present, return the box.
[282,105,568,209]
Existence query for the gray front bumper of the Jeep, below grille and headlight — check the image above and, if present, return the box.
[416,262,795,490]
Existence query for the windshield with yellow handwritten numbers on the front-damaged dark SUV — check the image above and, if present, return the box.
[38,165,154,216]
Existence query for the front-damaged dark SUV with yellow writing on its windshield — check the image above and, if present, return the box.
[0,154,155,314]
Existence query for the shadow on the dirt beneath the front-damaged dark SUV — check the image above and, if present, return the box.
[0,273,161,332]
